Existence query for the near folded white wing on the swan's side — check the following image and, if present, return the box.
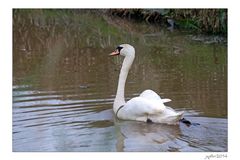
[123,97,166,116]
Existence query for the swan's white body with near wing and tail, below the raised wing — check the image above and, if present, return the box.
[118,97,183,124]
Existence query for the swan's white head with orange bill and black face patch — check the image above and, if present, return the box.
[109,44,135,57]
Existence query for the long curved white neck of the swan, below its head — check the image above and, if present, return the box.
[113,55,134,113]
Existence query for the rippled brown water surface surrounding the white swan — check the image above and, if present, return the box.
[12,10,228,152]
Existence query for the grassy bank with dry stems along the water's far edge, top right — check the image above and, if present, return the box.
[107,9,227,35]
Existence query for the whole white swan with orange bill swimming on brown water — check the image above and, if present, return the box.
[109,44,183,124]
